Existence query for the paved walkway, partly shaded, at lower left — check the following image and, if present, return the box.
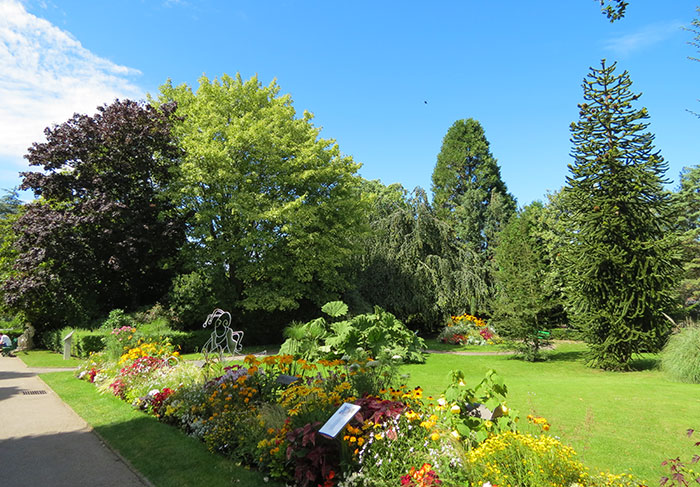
[0,357,149,487]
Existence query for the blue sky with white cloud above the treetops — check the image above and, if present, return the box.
[0,0,700,205]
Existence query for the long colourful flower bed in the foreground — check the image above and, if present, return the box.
[80,338,639,487]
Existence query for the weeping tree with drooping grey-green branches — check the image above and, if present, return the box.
[357,188,488,331]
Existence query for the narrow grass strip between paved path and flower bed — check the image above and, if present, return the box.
[40,372,279,487]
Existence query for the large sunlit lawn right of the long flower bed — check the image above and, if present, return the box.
[403,343,700,485]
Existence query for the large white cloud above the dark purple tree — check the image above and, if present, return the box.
[0,0,144,170]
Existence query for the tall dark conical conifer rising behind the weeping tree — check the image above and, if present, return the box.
[432,118,516,254]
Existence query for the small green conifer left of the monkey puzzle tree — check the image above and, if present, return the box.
[493,202,560,361]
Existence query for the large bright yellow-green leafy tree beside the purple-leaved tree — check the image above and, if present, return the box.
[159,75,365,311]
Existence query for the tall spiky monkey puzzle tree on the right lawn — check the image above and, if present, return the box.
[564,60,679,369]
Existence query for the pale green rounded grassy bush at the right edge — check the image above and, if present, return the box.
[661,323,700,384]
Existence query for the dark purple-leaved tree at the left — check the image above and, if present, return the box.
[3,100,184,327]
